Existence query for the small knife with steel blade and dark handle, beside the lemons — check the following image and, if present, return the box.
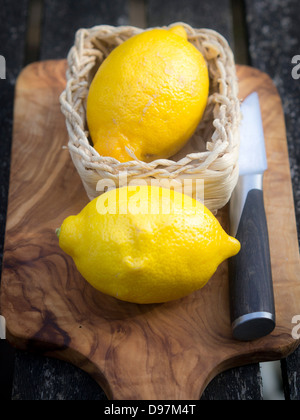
[229,92,275,341]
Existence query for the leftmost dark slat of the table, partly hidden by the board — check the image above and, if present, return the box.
[0,0,28,400]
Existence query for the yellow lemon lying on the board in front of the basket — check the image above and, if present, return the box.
[59,186,240,303]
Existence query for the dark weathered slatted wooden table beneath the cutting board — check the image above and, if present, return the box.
[0,0,300,400]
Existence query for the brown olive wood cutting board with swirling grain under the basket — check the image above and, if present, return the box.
[1,60,300,400]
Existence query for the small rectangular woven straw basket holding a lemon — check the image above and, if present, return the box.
[60,22,240,213]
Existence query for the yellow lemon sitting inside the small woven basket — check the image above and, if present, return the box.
[86,25,209,162]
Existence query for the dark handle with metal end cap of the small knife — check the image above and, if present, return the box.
[229,189,275,341]
